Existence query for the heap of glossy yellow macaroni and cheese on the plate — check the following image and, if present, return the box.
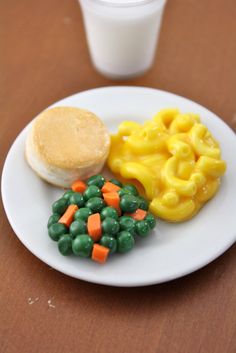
[108,109,226,222]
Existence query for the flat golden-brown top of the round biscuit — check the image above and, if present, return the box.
[32,107,110,168]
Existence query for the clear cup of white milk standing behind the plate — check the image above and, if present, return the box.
[79,0,166,79]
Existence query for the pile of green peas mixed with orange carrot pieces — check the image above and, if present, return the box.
[47,174,156,263]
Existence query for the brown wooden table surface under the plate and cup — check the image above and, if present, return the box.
[0,0,236,353]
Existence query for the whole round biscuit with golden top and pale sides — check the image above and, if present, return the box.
[25,107,110,188]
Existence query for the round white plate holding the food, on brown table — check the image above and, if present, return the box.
[2,87,236,287]
